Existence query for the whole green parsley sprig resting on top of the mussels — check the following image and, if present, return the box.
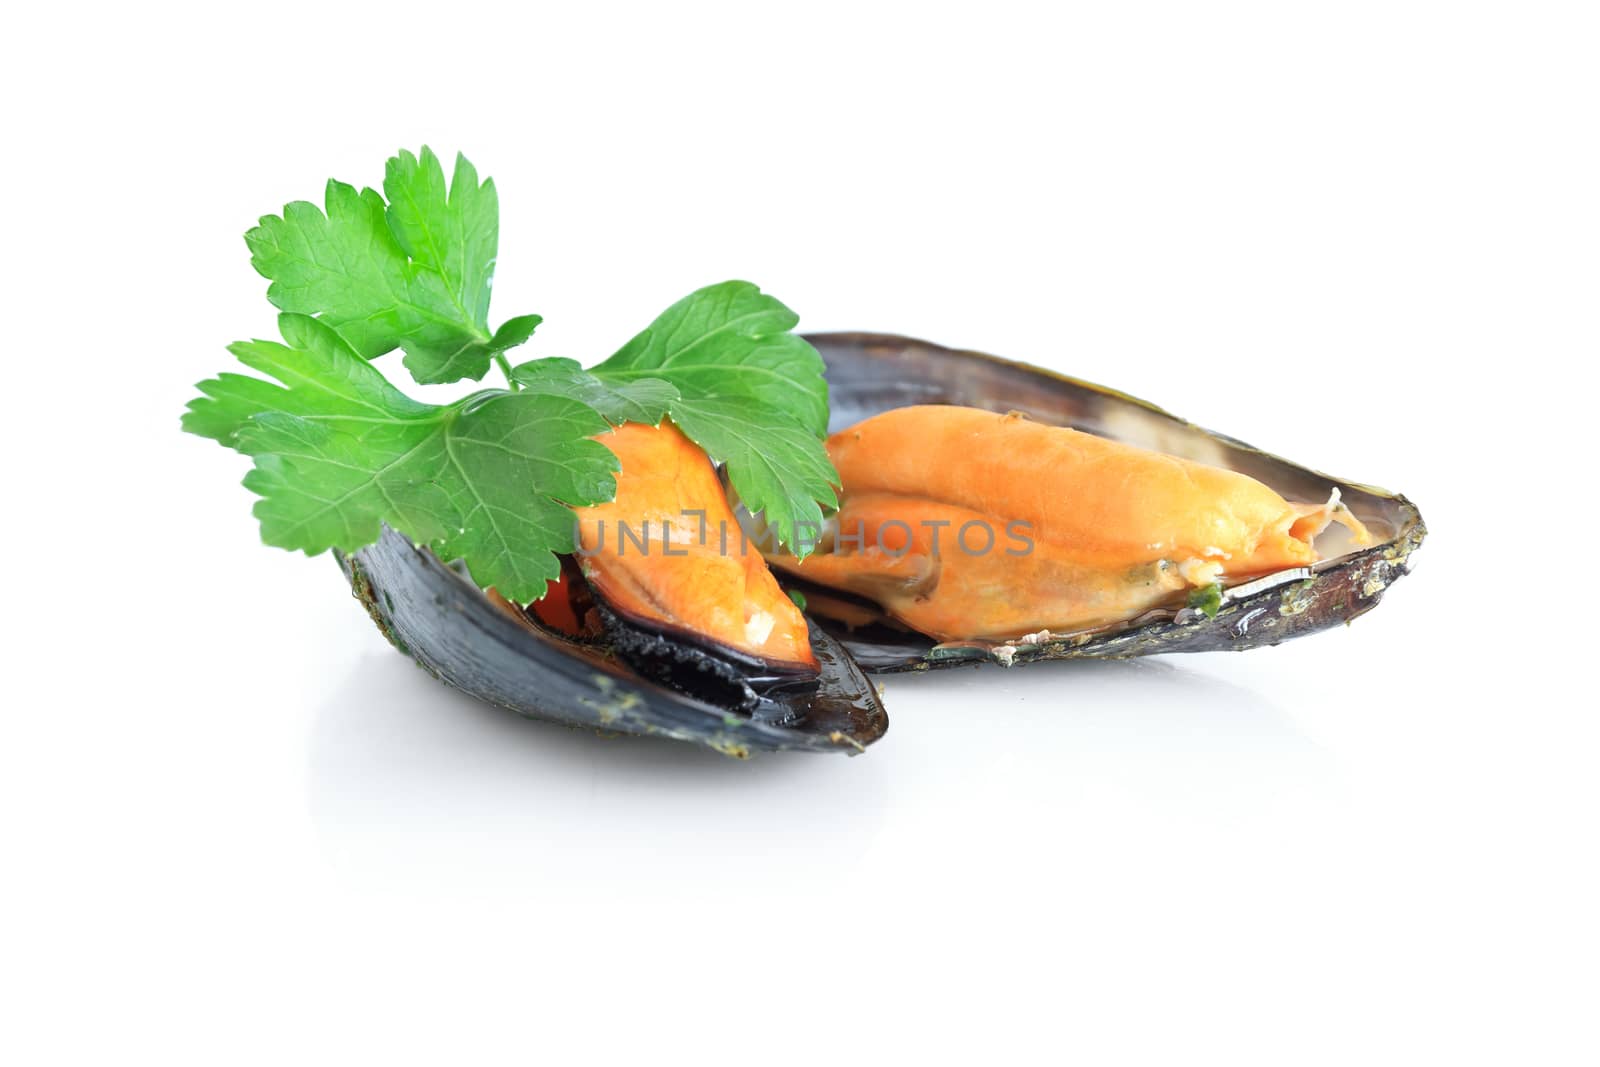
[182,147,837,600]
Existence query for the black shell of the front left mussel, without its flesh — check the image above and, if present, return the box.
[339,528,888,757]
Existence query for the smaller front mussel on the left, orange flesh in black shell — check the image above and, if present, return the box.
[346,412,888,755]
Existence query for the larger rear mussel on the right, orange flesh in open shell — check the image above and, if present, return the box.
[793,334,1426,670]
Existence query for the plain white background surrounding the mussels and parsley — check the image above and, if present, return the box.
[0,3,1600,1064]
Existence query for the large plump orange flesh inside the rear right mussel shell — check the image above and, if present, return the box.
[770,405,1370,641]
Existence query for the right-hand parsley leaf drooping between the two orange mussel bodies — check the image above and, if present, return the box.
[590,282,838,555]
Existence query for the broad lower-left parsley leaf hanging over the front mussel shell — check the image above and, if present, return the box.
[184,315,618,601]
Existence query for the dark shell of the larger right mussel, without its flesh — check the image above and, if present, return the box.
[802,333,1427,672]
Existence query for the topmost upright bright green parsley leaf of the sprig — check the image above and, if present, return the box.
[245,147,538,382]
